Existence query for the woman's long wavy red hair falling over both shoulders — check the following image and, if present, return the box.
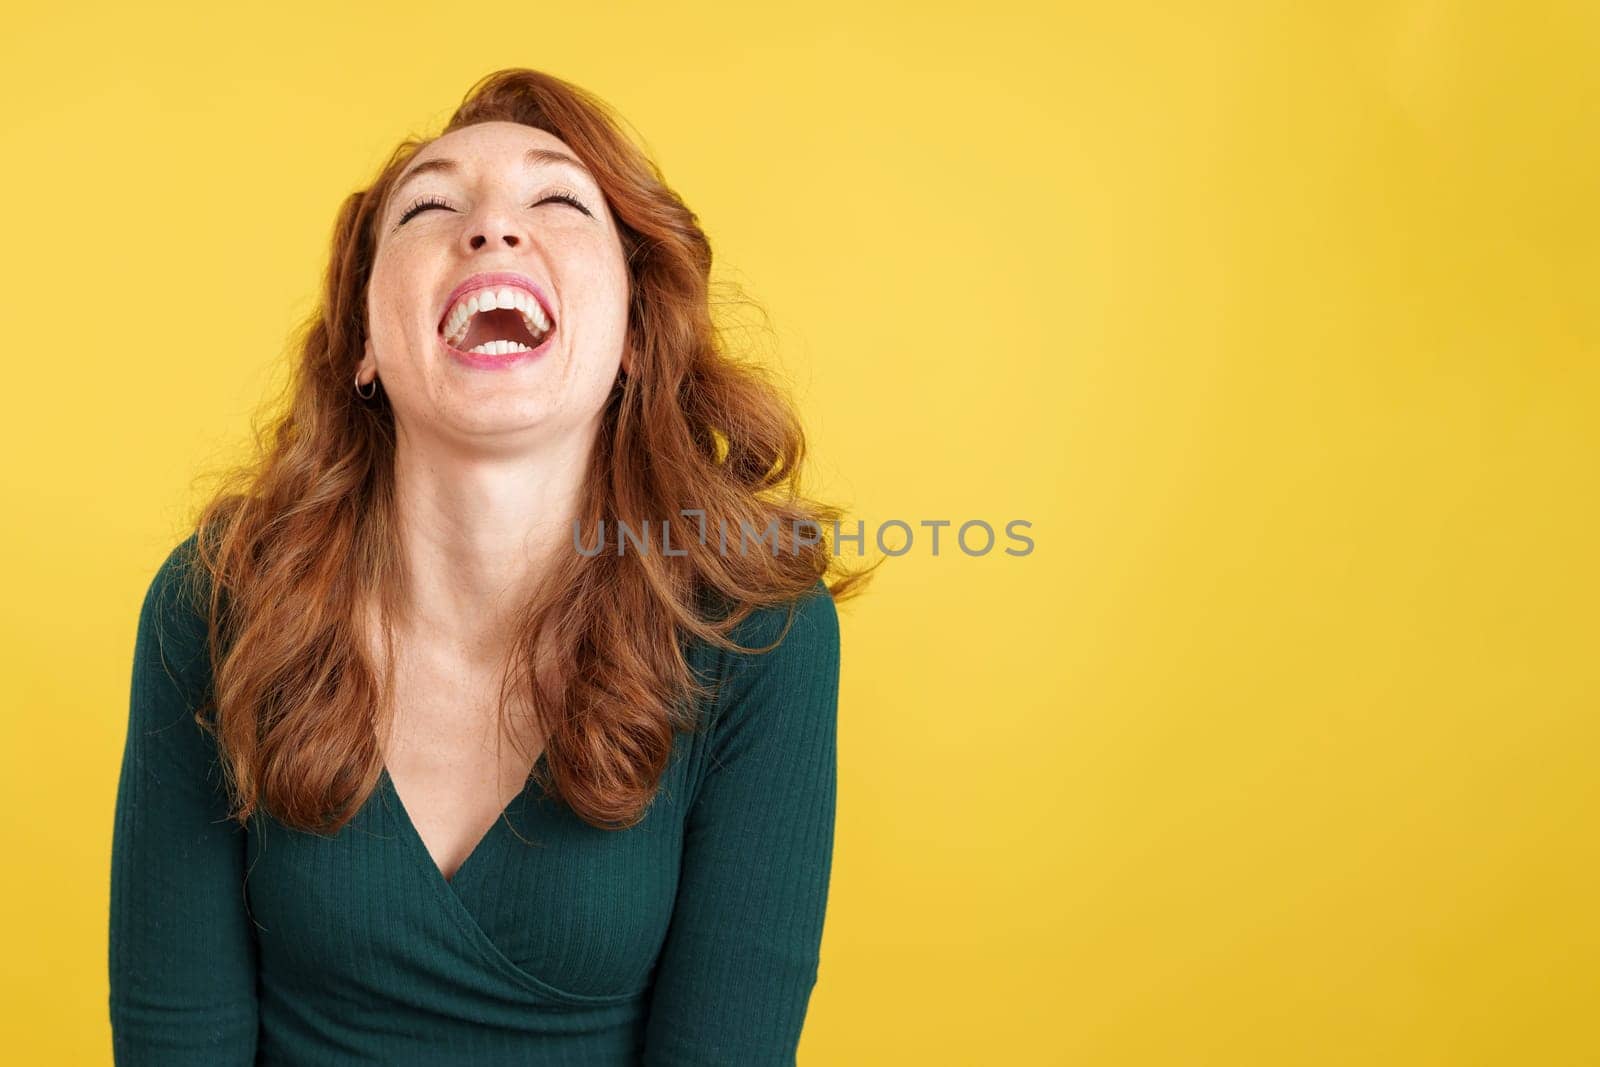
[192,69,875,832]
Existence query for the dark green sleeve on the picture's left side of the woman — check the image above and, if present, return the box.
[109,534,258,1067]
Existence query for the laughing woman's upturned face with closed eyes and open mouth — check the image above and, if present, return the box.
[363,122,629,451]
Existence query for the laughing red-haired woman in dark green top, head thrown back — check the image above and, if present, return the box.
[110,70,867,1067]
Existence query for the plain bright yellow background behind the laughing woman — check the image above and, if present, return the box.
[0,0,1600,1065]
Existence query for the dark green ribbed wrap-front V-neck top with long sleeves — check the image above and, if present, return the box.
[109,534,838,1067]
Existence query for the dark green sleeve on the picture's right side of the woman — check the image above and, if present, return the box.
[643,581,838,1067]
